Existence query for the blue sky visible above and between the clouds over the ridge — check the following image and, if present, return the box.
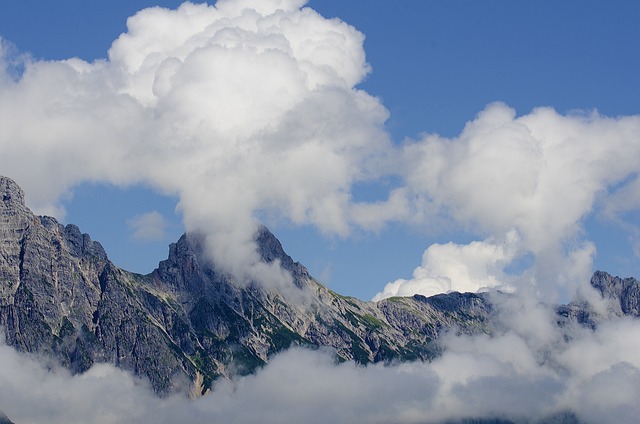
[0,0,640,299]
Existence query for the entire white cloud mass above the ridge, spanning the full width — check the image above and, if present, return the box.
[0,0,640,300]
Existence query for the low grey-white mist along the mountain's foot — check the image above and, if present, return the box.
[0,286,640,423]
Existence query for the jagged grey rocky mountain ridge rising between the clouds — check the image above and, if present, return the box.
[0,177,638,395]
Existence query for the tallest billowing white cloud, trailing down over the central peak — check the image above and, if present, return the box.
[0,0,398,288]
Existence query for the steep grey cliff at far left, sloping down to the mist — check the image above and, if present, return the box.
[0,178,198,391]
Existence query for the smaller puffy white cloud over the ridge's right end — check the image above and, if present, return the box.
[376,103,640,301]
